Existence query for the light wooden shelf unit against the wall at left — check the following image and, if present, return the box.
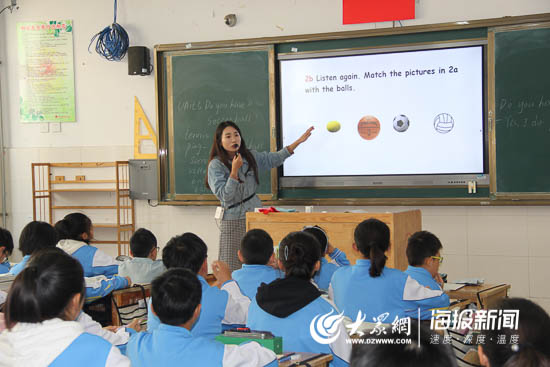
[32,161,135,255]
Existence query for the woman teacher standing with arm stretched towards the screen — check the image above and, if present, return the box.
[205,121,313,271]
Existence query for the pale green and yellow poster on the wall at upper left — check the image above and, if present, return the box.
[17,20,75,122]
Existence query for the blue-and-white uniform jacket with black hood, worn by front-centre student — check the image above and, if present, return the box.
[247,277,351,366]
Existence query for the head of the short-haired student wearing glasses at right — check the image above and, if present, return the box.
[407,231,443,276]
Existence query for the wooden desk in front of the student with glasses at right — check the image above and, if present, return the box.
[446,284,511,309]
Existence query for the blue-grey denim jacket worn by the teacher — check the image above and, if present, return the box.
[208,147,290,220]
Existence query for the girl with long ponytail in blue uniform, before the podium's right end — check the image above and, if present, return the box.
[329,218,443,323]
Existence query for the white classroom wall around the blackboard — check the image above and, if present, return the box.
[0,0,550,310]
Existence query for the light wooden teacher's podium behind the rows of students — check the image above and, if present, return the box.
[246,210,422,270]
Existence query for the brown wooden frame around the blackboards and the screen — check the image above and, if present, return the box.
[155,13,550,206]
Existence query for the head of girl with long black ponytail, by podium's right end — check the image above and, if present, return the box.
[353,218,390,277]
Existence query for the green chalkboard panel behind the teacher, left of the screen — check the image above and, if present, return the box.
[165,47,273,200]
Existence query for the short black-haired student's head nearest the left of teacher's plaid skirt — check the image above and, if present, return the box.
[162,232,208,276]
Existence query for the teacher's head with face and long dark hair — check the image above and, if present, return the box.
[205,121,260,188]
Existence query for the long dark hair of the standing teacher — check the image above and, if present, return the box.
[204,121,260,189]
